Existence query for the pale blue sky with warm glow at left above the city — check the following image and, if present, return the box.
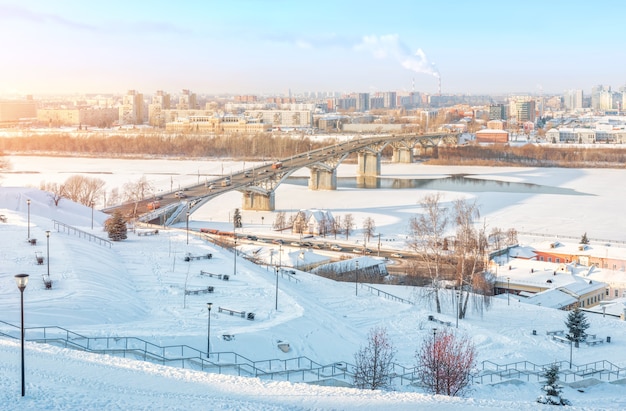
[0,0,626,95]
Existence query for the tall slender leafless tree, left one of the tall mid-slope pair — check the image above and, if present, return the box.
[408,193,449,313]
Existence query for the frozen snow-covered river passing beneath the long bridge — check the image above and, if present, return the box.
[2,156,626,241]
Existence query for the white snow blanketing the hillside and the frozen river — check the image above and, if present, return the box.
[0,157,626,410]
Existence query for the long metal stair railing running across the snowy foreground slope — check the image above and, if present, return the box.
[0,320,626,385]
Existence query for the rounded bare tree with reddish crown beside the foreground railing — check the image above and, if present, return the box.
[416,329,476,396]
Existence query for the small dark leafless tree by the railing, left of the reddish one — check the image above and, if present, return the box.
[354,328,396,390]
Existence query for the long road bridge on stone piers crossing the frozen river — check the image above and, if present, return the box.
[113,133,458,225]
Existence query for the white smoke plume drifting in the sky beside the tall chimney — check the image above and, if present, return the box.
[355,34,439,77]
